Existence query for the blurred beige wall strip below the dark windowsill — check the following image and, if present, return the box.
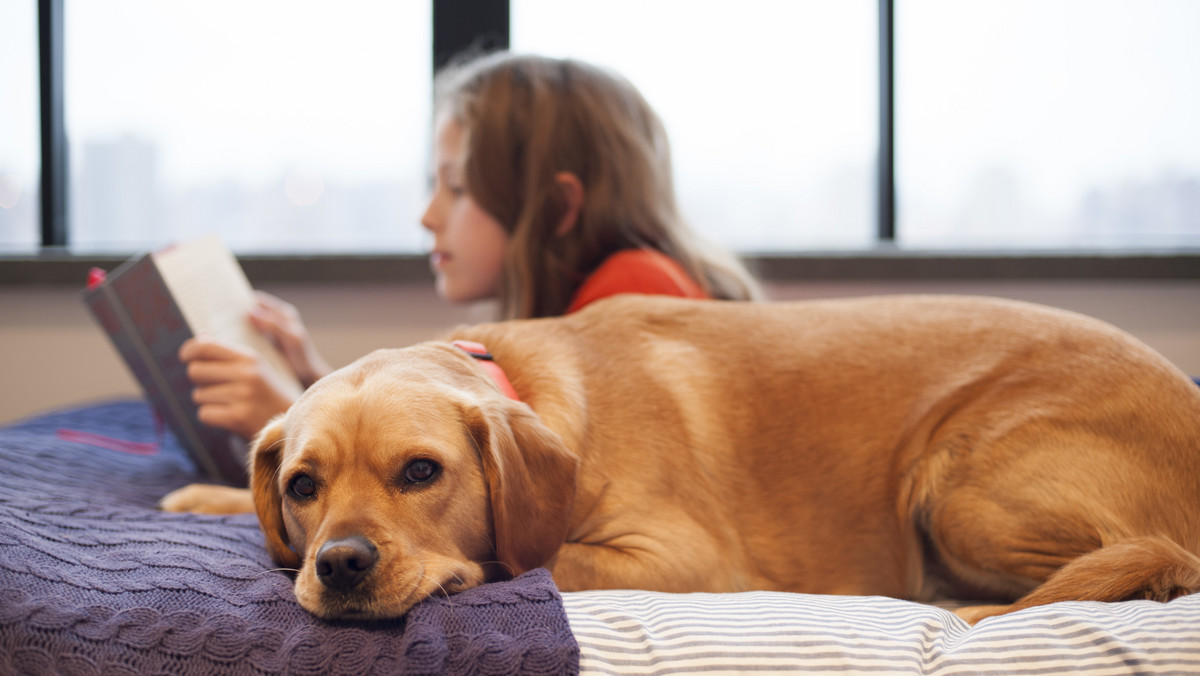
[0,280,1200,423]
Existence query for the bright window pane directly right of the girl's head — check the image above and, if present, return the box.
[511,0,878,251]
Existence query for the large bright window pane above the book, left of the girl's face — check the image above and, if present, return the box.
[65,0,432,252]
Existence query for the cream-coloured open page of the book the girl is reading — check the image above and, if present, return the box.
[154,234,302,395]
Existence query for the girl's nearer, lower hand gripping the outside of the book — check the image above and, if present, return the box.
[179,336,295,439]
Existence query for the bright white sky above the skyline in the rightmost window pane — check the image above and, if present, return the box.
[896,0,1200,211]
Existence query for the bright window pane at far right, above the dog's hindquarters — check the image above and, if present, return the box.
[896,0,1200,247]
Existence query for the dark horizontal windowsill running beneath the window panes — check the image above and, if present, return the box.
[0,247,1200,287]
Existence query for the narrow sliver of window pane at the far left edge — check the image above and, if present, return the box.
[0,0,42,252]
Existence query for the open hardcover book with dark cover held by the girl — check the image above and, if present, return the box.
[83,235,302,485]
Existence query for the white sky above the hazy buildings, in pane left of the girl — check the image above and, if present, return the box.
[66,0,432,183]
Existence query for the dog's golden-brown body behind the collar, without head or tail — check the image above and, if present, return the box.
[462,297,1200,614]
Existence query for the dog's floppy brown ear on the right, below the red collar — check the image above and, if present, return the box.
[466,400,580,576]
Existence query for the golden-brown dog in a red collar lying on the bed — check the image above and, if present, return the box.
[159,295,1200,622]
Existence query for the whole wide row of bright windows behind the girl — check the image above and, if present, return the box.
[11,0,1200,258]
